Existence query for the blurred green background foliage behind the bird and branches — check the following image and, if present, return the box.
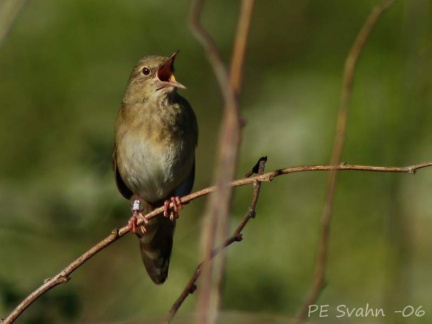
[0,0,432,323]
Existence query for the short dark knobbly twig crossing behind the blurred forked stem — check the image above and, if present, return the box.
[167,157,267,323]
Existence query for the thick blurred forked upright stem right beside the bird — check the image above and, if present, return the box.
[190,0,254,323]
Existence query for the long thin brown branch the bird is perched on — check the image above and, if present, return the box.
[0,162,432,324]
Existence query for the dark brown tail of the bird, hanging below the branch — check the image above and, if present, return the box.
[137,205,175,284]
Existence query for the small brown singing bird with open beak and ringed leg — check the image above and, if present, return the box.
[113,51,198,284]
